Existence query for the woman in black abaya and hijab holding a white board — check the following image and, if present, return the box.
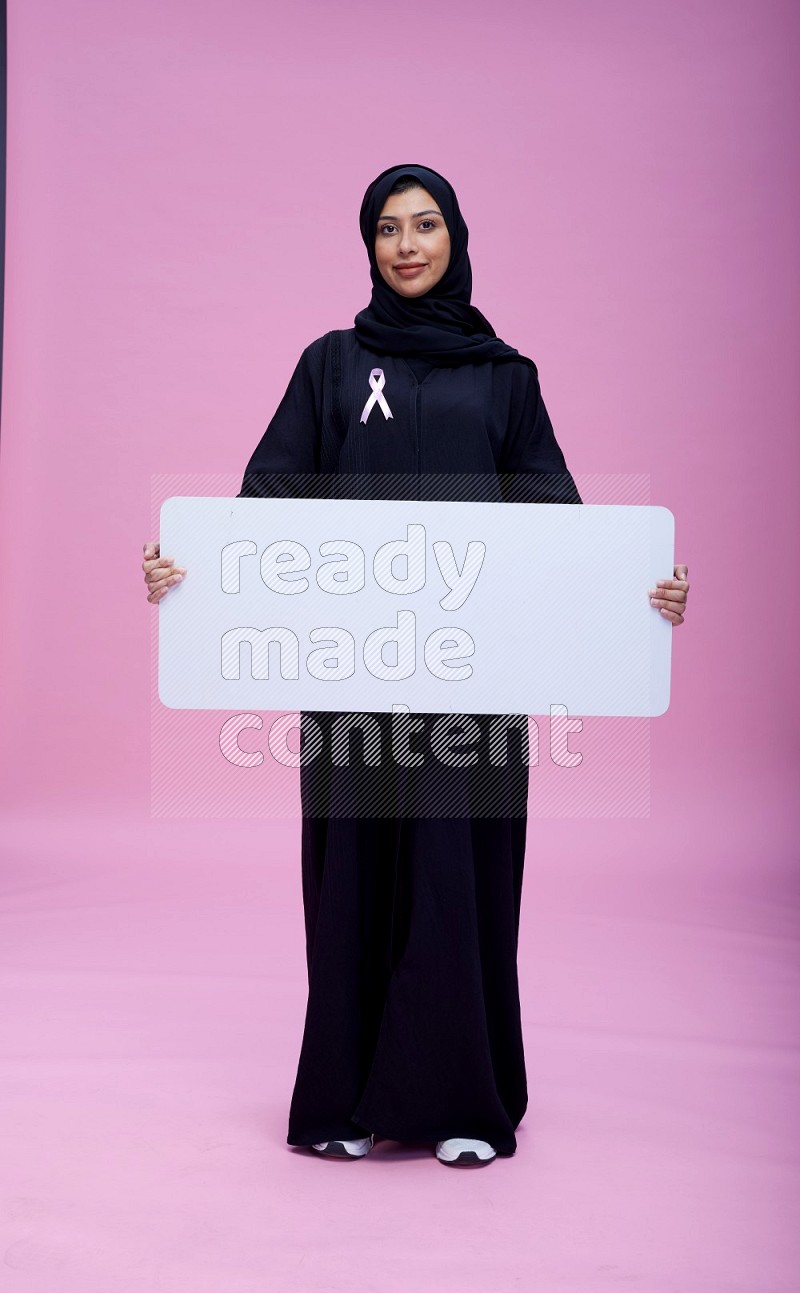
[143,164,689,1166]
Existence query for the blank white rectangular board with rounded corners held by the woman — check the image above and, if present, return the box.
[158,498,675,716]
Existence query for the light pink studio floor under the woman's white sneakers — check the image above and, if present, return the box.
[0,803,800,1293]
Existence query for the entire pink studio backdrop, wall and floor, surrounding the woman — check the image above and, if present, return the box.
[0,0,800,1293]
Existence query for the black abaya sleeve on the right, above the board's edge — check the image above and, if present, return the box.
[499,363,582,503]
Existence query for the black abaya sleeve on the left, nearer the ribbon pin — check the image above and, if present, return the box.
[237,337,326,498]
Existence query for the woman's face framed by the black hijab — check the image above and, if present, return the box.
[375,189,450,296]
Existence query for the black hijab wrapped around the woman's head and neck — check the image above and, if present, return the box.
[354,166,536,371]
